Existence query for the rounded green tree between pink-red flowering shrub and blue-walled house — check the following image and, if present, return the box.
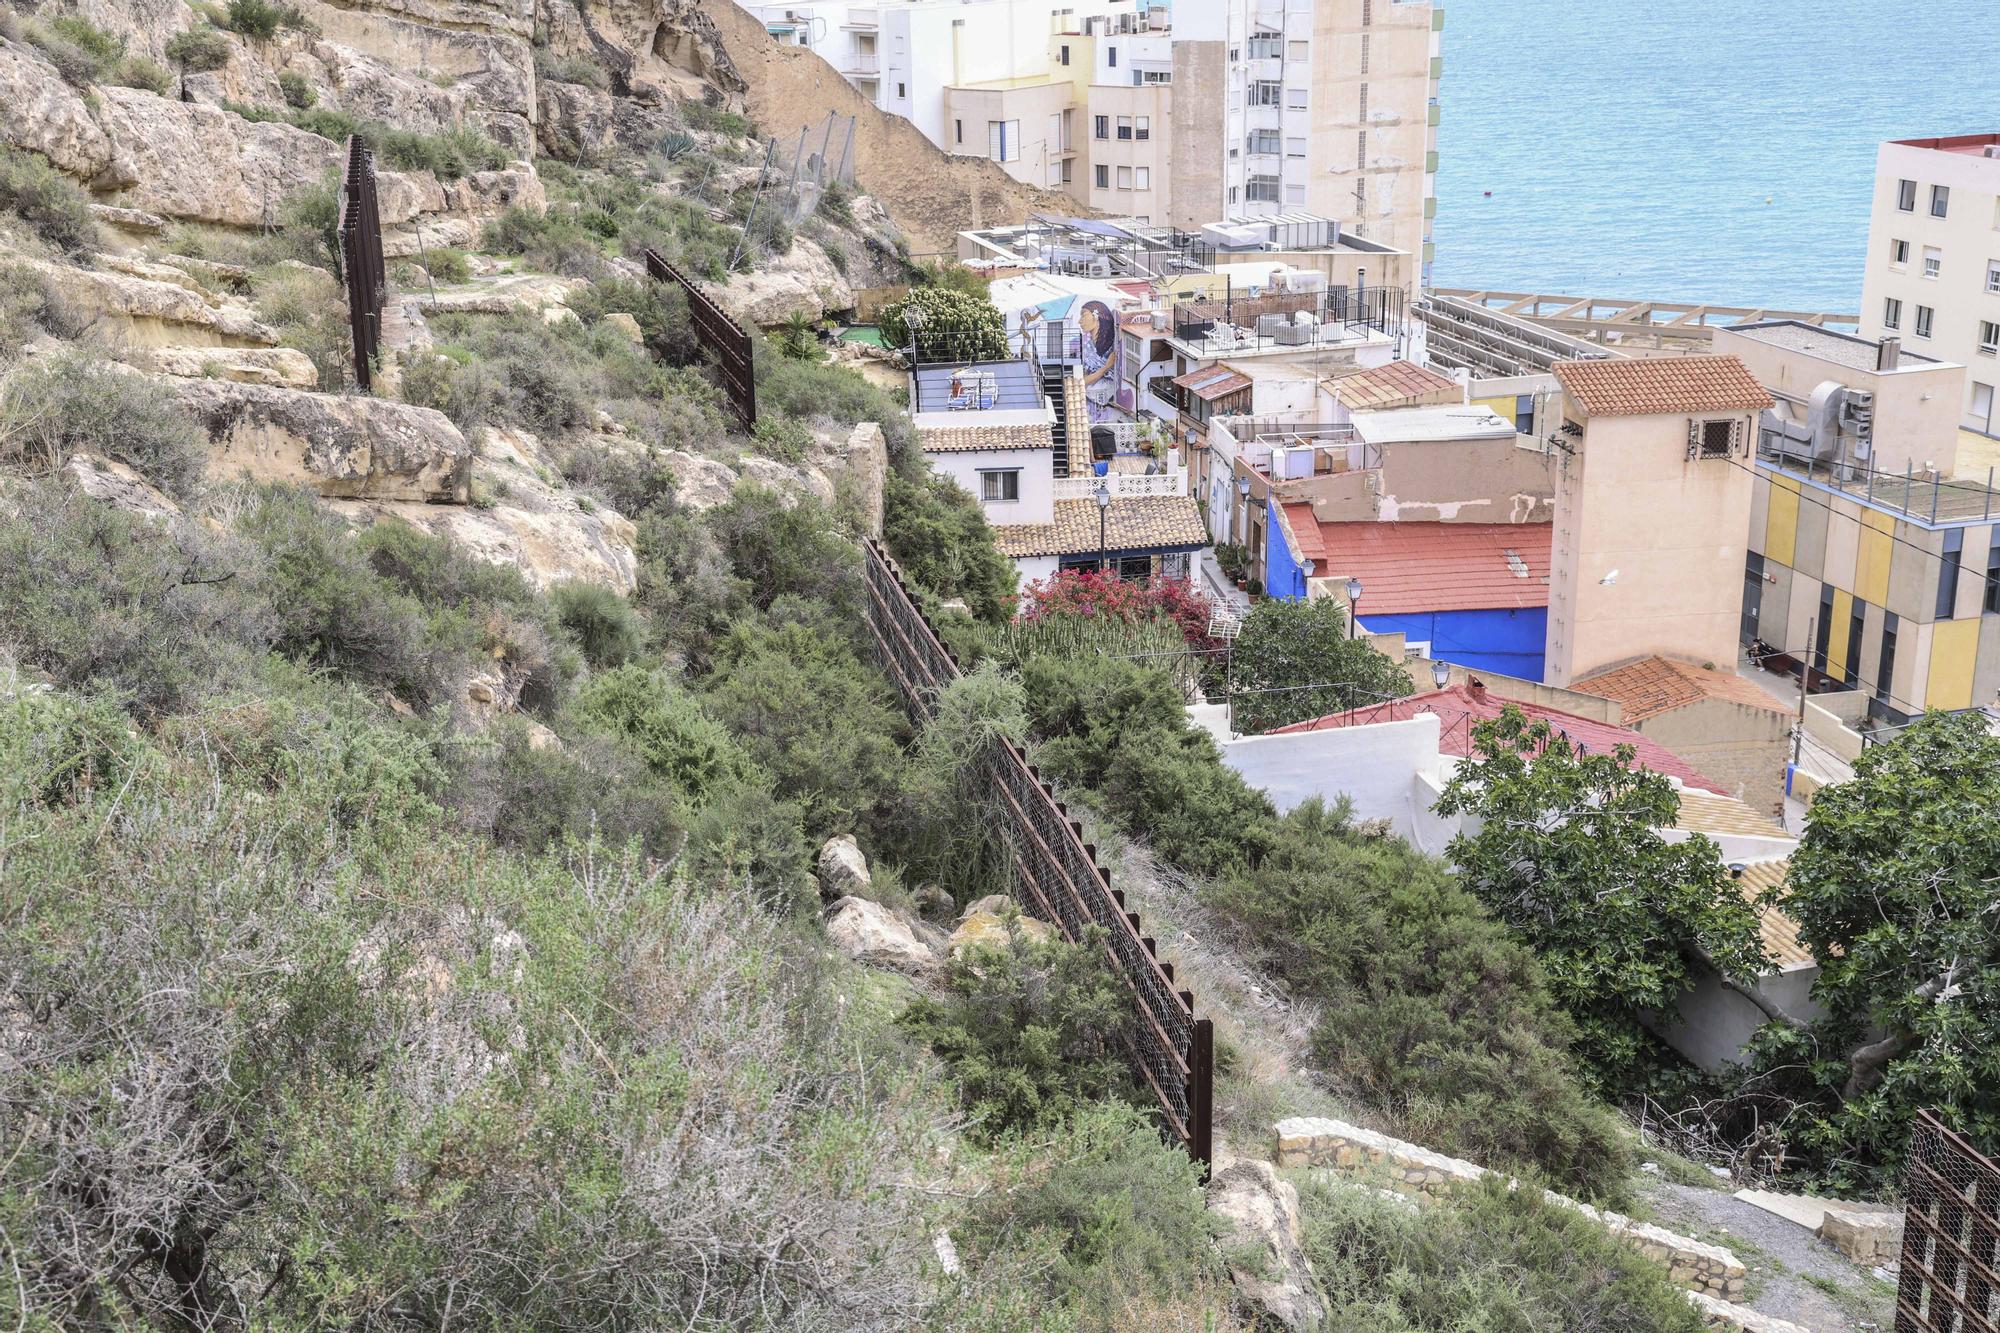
[1232,598,1410,733]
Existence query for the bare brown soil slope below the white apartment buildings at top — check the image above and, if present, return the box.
[708,2,1086,254]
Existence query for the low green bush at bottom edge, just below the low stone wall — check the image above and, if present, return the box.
[1300,1177,1706,1333]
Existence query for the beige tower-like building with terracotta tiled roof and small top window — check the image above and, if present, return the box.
[1544,356,1772,689]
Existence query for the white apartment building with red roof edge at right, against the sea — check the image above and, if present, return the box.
[1860,134,2000,434]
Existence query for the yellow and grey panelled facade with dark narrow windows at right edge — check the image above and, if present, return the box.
[1742,456,2000,723]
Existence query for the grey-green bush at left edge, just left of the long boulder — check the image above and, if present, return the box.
[0,352,208,498]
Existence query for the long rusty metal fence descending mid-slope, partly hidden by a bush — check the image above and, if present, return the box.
[866,538,1214,1173]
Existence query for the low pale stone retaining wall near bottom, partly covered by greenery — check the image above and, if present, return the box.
[1276,1117,1748,1296]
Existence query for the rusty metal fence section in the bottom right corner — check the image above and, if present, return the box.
[1896,1111,2000,1333]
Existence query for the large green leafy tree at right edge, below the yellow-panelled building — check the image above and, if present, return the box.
[1768,713,2000,1167]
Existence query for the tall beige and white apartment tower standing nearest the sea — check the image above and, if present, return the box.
[1170,0,1444,280]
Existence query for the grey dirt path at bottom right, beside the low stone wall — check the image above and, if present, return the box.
[1644,1181,1896,1333]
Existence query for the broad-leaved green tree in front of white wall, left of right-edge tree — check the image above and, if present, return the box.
[1438,707,1764,1079]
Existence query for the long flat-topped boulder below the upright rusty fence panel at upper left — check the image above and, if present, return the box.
[162,380,472,504]
